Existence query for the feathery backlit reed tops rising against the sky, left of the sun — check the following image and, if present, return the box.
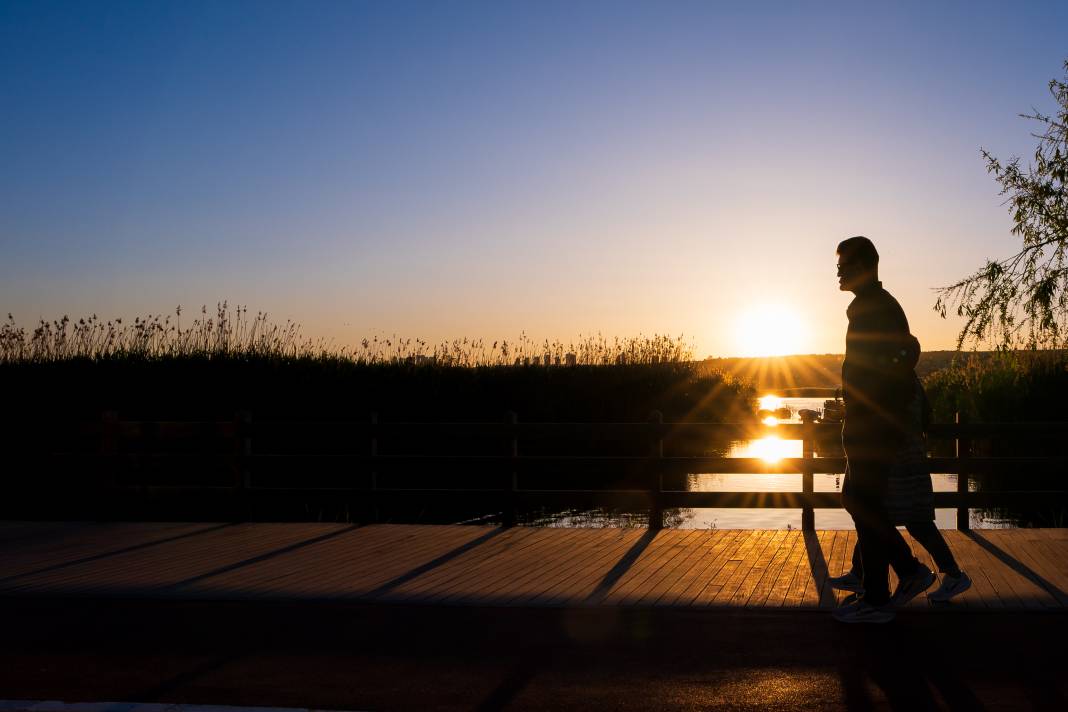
[0,302,693,368]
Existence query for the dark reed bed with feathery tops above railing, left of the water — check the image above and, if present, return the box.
[0,302,755,422]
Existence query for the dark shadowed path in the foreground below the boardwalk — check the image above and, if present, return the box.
[0,599,1068,712]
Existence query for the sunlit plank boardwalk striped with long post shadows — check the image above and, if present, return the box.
[0,522,1068,611]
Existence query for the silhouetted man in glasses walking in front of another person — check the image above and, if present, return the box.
[834,237,935,622]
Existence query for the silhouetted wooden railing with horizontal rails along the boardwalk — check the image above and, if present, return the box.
[35,412,1068,529]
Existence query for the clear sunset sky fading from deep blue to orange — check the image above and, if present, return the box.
[0,0,1068,357]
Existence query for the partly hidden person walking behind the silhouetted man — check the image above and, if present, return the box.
[828,375,972,602]
